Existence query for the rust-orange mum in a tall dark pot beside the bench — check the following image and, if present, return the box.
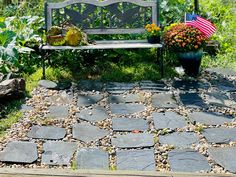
[163,23,207,77]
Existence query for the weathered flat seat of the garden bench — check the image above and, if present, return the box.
[42,40,162,50]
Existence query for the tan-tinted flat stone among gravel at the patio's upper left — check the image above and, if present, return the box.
[48,91,73,104]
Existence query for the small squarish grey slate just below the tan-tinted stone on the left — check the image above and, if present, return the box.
[47,105,69,119]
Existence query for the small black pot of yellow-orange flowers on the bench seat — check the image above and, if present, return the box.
[145,23,161,44]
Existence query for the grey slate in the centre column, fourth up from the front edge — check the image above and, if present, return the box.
[110,103,145,115]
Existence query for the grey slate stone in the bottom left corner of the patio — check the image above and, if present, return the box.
[0,141,38,163]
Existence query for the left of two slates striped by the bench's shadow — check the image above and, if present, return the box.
[106,82,135,94]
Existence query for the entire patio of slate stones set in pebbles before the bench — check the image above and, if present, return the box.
[0,71,236,173]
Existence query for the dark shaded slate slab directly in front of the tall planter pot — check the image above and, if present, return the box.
[173,80,209,91]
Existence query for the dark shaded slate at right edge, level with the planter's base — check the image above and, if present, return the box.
[210,78,236,92]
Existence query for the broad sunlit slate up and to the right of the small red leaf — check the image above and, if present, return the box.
[152,112,187,130]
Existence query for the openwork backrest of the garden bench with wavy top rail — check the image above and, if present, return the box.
[45,0,160,34]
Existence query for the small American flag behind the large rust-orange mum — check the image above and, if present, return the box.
[185,13,216,38]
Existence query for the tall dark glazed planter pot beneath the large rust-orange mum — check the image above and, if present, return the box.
[177,49,203,77]
